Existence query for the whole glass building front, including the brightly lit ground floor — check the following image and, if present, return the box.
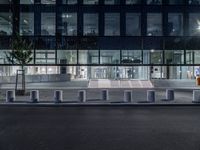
[0,0,200,79]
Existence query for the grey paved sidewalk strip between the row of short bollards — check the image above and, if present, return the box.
[0,88,193,104]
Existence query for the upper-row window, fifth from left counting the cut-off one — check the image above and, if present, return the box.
[84,14,99,36]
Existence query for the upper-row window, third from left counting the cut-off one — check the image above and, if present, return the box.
[41,13,56,35]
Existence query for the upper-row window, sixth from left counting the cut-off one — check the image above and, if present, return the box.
[104,13,120,36]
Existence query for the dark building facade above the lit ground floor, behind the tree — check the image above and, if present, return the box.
[0,0,200,65]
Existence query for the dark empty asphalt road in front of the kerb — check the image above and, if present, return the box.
[0,106,200,150]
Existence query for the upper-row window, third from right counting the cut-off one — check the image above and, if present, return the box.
[147,13,162,36]
